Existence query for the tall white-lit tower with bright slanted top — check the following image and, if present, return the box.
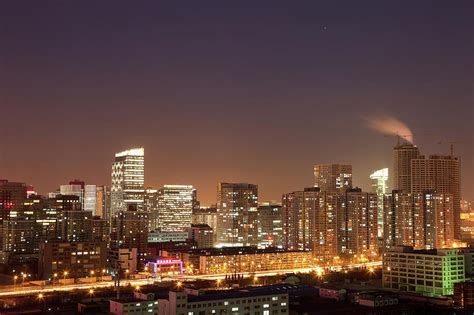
[111,148,145,215]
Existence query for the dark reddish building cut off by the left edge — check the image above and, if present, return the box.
[0,179,27,223]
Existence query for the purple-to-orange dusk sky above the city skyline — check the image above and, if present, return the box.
[0,0,474,204]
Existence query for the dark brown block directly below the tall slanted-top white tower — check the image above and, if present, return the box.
[110,211,148,267]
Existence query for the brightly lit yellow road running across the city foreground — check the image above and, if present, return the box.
[0,261,382,297]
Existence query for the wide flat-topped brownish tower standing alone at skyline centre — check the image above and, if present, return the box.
[216,183,258,246]
